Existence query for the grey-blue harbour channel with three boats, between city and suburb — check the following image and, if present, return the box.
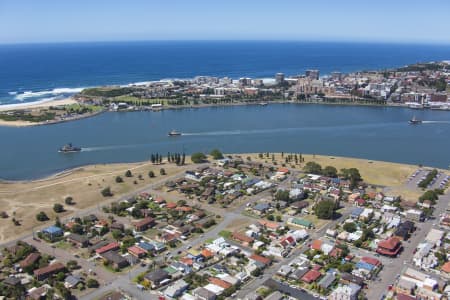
[0,104,450,180]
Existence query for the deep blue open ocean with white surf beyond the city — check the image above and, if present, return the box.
[0,41,450,104]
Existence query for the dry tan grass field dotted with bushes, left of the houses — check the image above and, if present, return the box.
[0,162,187,242]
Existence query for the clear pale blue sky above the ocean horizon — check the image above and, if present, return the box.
[0,0,450,44]
